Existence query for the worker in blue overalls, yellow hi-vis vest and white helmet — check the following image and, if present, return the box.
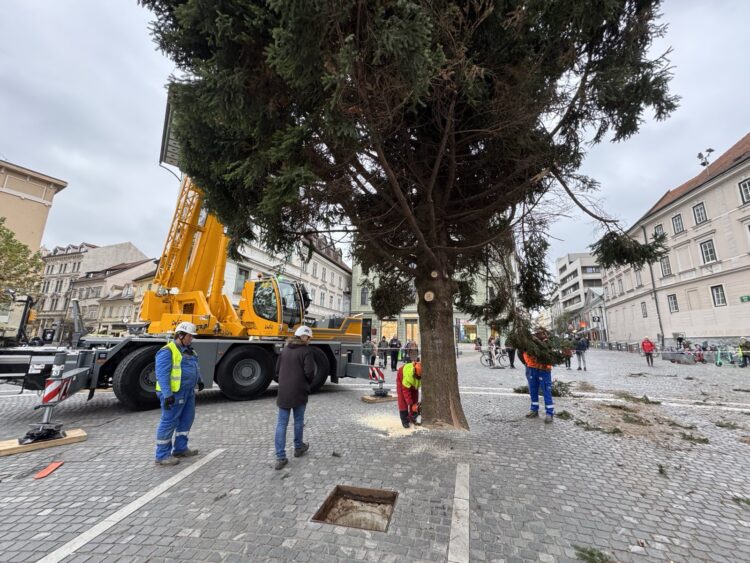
[156,322,204,465]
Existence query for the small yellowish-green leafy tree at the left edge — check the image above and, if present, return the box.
[0,217,43,303]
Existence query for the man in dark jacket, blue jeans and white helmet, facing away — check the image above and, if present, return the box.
[275,325,315,469]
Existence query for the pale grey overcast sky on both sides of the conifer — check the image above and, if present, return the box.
[0,0,750,270]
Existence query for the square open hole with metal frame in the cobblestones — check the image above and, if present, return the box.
[312,485,398,532]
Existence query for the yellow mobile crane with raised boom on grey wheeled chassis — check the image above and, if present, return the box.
[0,178,368,414]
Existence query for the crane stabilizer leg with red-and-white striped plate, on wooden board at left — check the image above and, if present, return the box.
[18,352,89,446]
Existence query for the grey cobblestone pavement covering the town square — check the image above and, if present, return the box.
[0,349,750,562]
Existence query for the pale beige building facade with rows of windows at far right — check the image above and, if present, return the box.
[603,134,750,346]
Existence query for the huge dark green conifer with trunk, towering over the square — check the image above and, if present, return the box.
[141,0,676,428]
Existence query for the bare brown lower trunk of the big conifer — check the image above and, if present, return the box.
[416,276,469,430]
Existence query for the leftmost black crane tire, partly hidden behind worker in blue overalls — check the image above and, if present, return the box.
[112,346,159,411]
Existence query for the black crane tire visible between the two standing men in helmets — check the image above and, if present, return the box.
[216,346,273,401]
